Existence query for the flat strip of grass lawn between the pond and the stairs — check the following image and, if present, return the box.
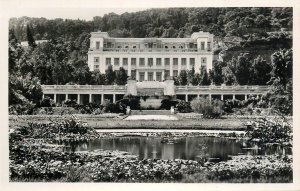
[9,114,248,130]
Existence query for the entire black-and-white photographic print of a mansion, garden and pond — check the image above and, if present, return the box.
[1,1,300,190]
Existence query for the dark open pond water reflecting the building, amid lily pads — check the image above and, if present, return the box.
[66,136,292,161]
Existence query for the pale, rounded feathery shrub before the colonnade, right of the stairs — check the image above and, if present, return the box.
[191,97,223,118]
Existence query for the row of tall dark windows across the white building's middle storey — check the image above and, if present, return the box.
[94,57,207,67]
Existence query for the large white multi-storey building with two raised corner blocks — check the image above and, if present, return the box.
[88,31,213,81]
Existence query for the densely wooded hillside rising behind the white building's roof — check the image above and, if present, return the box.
[10,8,293,41]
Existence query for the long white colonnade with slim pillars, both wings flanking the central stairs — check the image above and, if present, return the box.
[42,85,268,104]
